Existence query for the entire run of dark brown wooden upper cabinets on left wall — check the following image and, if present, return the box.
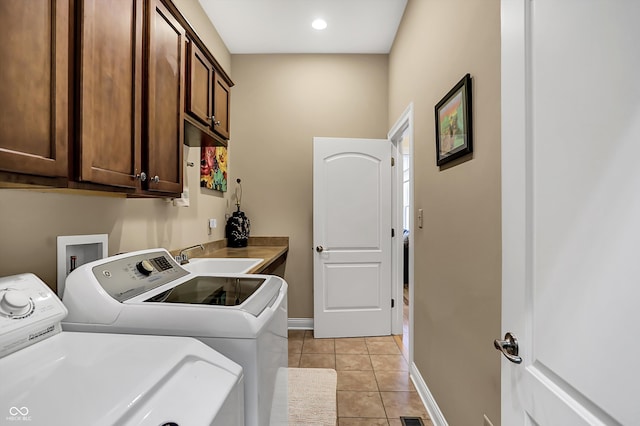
[0,0,220,197]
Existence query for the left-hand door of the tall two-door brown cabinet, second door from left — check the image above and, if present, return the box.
[77,0,143,188]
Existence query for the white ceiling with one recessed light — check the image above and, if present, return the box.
[199,0,407,54]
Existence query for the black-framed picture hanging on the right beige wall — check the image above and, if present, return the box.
[435,74,473,166]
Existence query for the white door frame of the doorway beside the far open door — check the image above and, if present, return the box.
[387,102,415,365]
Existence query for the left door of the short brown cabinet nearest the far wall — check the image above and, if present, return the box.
[187,42,214,126]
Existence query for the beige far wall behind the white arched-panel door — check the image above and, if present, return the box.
[230,55,388,318]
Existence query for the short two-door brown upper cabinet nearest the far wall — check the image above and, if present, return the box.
[186,41,230,140]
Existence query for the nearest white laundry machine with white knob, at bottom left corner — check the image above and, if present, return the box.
[0,274,244,426]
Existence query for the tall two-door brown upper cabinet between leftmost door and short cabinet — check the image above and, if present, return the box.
[77,0,186,194]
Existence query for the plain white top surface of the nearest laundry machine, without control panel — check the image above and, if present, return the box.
[0,332,242,426]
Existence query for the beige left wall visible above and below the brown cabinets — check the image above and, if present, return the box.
[0,0,233,288]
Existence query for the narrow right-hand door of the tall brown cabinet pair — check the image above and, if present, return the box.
[145,0,186,194]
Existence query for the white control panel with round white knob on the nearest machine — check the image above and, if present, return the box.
[0,274,67,358]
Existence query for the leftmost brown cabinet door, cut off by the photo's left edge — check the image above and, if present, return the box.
[0,0,69,177]
